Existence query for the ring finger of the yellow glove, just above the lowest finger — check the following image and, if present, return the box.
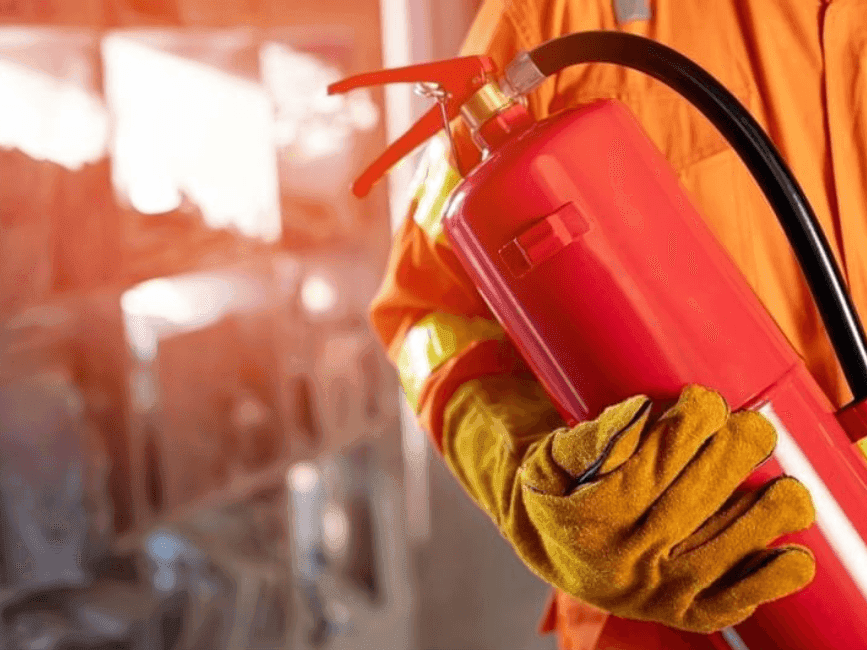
[679,477,815,586]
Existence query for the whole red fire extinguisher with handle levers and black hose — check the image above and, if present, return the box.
[329,32,867,650]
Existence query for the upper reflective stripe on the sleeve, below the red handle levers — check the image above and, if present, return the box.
[413,135,461,244]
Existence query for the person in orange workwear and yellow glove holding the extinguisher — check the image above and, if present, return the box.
[371,0,867,650]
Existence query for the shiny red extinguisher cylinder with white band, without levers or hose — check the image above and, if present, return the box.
[444,100,867,650]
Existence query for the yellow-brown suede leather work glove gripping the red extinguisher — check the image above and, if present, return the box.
[443,376,815,632]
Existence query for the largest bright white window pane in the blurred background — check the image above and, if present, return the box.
[103,34,281,241]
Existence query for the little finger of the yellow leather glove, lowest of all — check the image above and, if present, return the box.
[687,545,816,630]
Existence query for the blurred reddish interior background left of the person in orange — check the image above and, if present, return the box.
[0,0,553,650]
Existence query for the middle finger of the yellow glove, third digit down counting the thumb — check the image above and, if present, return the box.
[639,412,777,547]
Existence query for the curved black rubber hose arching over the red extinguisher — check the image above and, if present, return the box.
[529,31,867,402]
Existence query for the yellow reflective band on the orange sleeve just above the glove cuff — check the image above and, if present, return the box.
[397,313,504,410]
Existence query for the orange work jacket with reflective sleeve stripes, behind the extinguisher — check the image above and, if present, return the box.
[372,0,867,650]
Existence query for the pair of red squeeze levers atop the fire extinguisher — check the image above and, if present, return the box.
[328,56,497,197]
